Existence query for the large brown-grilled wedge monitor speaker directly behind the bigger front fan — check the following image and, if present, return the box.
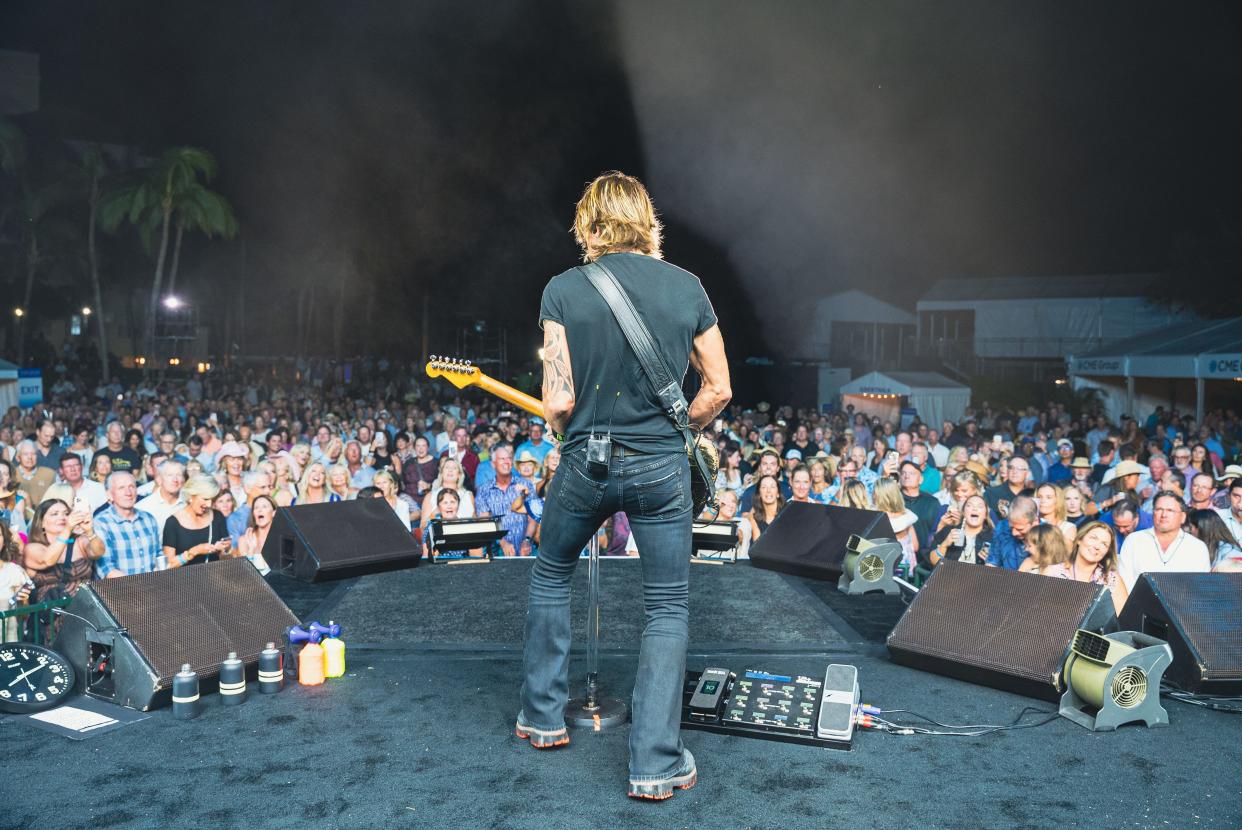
[888,560,1117,701]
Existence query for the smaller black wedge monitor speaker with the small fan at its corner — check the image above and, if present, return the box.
[750,502,893,579]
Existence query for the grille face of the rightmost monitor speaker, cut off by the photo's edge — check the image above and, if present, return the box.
[1144,573,1242,680]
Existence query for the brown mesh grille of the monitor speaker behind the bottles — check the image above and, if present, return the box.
[91,559,298,690]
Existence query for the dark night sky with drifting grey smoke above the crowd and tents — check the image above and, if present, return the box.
[0,0,1242,354]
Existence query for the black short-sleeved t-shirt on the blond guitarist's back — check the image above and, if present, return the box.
[539,253,717,452]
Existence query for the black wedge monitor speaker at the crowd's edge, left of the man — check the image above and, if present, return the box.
[263,498,422,583]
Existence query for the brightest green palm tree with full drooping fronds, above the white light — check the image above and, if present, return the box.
[99,147,237,365]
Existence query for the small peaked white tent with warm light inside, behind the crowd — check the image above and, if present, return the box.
[841,372,970,426]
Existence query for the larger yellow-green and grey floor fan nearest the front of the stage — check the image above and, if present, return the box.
[1061,629,1172,732]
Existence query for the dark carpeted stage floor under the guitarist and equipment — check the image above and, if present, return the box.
[0,560,1242,830]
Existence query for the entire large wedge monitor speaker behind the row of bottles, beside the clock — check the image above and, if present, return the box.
[56,559,298,712]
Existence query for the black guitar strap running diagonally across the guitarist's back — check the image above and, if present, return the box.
[580,262,715,504]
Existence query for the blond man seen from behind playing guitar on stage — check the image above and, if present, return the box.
[517,173,732,799]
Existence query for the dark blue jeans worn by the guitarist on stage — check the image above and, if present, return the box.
[522,449,692,780]
